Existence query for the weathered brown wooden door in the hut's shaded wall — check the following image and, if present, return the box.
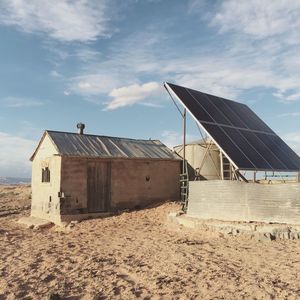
[87,162,110,212]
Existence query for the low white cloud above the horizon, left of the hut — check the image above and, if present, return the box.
[0,132,37,177]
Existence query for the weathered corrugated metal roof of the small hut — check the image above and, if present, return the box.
[46,131,179,159]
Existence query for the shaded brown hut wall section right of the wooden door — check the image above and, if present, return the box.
[111,159,180,209]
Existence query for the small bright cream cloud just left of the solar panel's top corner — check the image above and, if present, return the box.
[106,82,162,110]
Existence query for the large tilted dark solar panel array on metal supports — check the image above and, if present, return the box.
[165,83,300,171]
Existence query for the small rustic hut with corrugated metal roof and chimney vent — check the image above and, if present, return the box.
[30,124,181,224]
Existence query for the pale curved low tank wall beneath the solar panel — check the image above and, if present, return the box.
[187,180,300,224]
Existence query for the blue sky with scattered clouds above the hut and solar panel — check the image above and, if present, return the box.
[0,0,300,177]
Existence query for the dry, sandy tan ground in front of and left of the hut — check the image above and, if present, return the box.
[0,186,300,300]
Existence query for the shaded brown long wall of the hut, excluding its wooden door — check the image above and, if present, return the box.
[61,157,180,214]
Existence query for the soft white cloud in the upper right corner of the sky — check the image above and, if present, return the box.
[212,0,300,43]
